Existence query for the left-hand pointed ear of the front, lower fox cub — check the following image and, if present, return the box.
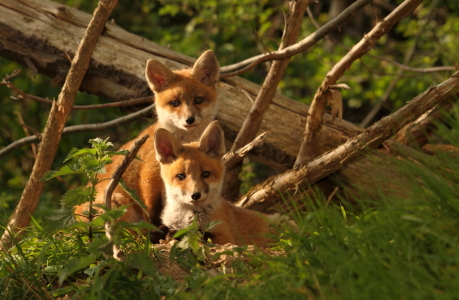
[155,128,182,164]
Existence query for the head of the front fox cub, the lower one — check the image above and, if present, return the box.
[155,121,225,207]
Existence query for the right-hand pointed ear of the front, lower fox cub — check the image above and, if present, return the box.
[199,121,226,158]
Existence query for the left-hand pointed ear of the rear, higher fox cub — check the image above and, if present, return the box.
[145,59,175,92]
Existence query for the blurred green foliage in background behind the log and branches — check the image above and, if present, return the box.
[0,0,459,220]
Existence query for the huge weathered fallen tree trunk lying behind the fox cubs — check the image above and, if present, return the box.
[0,0,360,170]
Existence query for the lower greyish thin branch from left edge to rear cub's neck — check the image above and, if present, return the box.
[0,104,155,157]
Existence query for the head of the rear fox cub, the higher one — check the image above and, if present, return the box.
[145,50,220,132]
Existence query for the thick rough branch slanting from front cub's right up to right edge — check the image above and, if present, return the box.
[238,72,459,210]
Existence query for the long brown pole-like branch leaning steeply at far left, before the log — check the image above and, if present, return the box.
[0,0,118,251]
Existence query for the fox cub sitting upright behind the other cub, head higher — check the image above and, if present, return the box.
[75,50,220,226]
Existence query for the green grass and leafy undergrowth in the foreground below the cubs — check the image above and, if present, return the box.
[0,108,459,299]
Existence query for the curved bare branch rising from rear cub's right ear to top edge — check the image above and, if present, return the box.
[220,0,371,79]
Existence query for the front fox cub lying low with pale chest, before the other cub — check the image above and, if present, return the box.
[155,121,278,247]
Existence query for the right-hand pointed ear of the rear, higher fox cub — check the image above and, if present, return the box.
[191,50,220,86]
